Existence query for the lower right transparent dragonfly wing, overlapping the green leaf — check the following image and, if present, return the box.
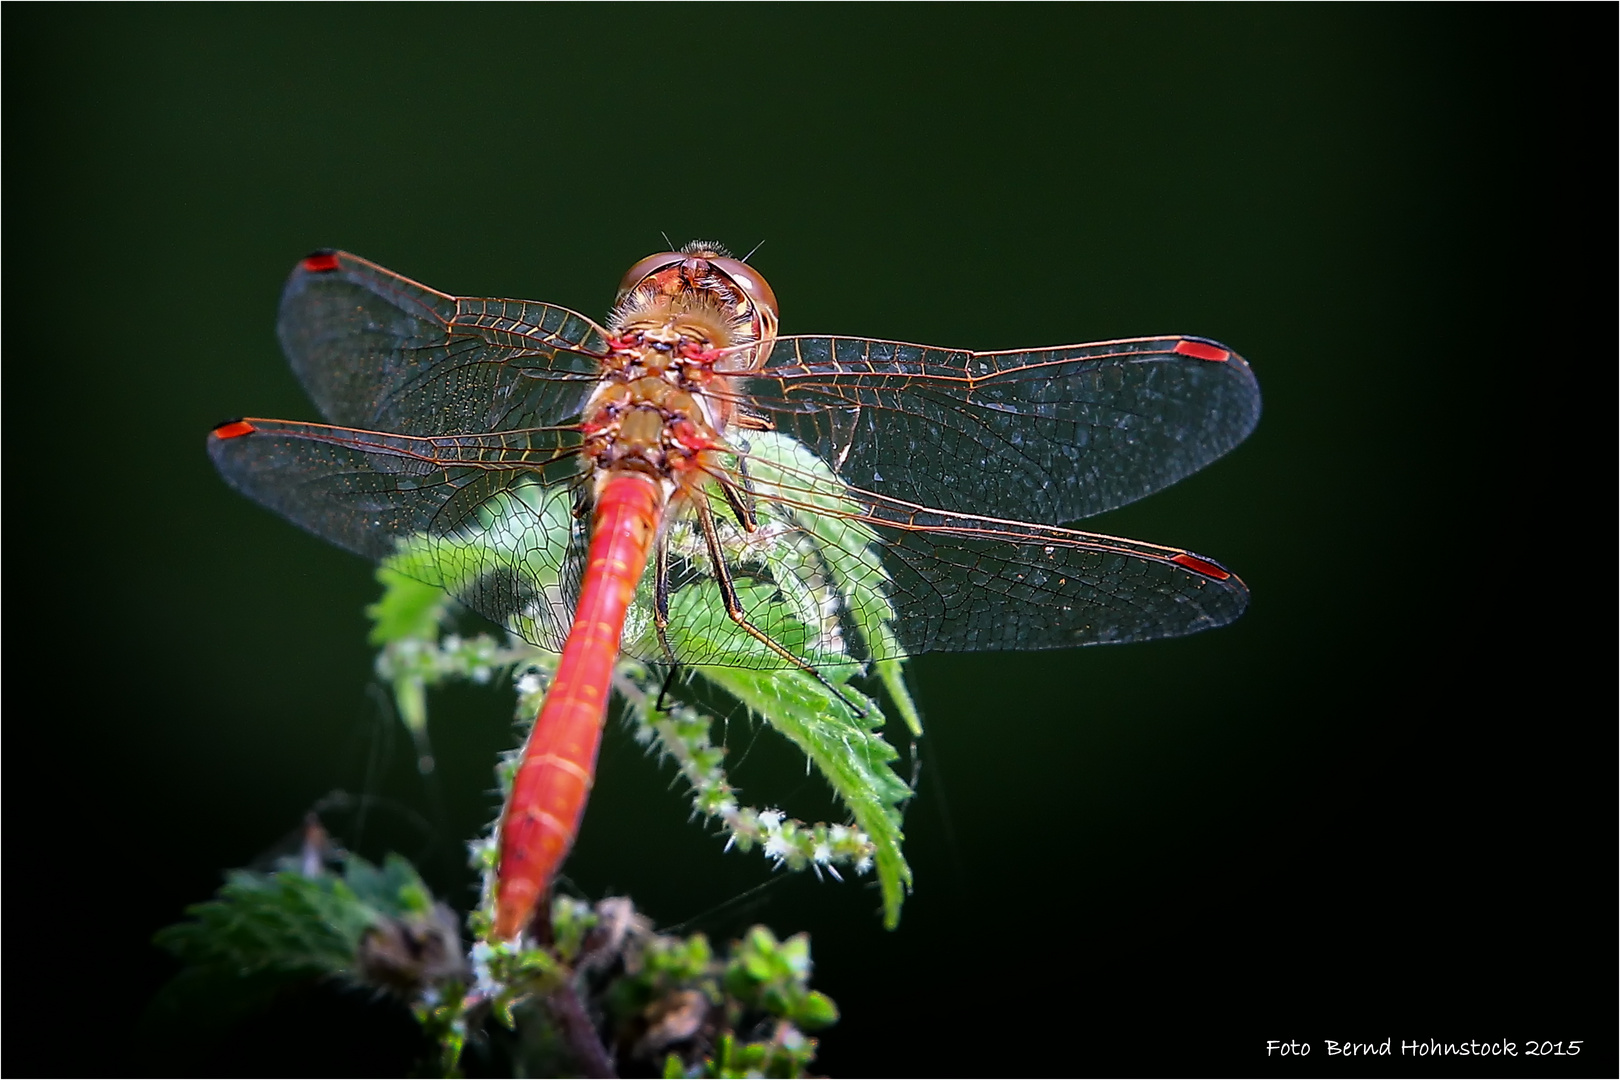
[625,432,1249,669]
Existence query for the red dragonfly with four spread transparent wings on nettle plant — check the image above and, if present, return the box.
[209,241,1260,939]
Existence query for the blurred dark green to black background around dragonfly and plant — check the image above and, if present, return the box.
[5,5,1615,1075]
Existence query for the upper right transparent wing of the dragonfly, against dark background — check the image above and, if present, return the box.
[739,335,1260,525]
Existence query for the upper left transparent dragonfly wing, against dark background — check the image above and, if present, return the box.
[277,251,606,436]
